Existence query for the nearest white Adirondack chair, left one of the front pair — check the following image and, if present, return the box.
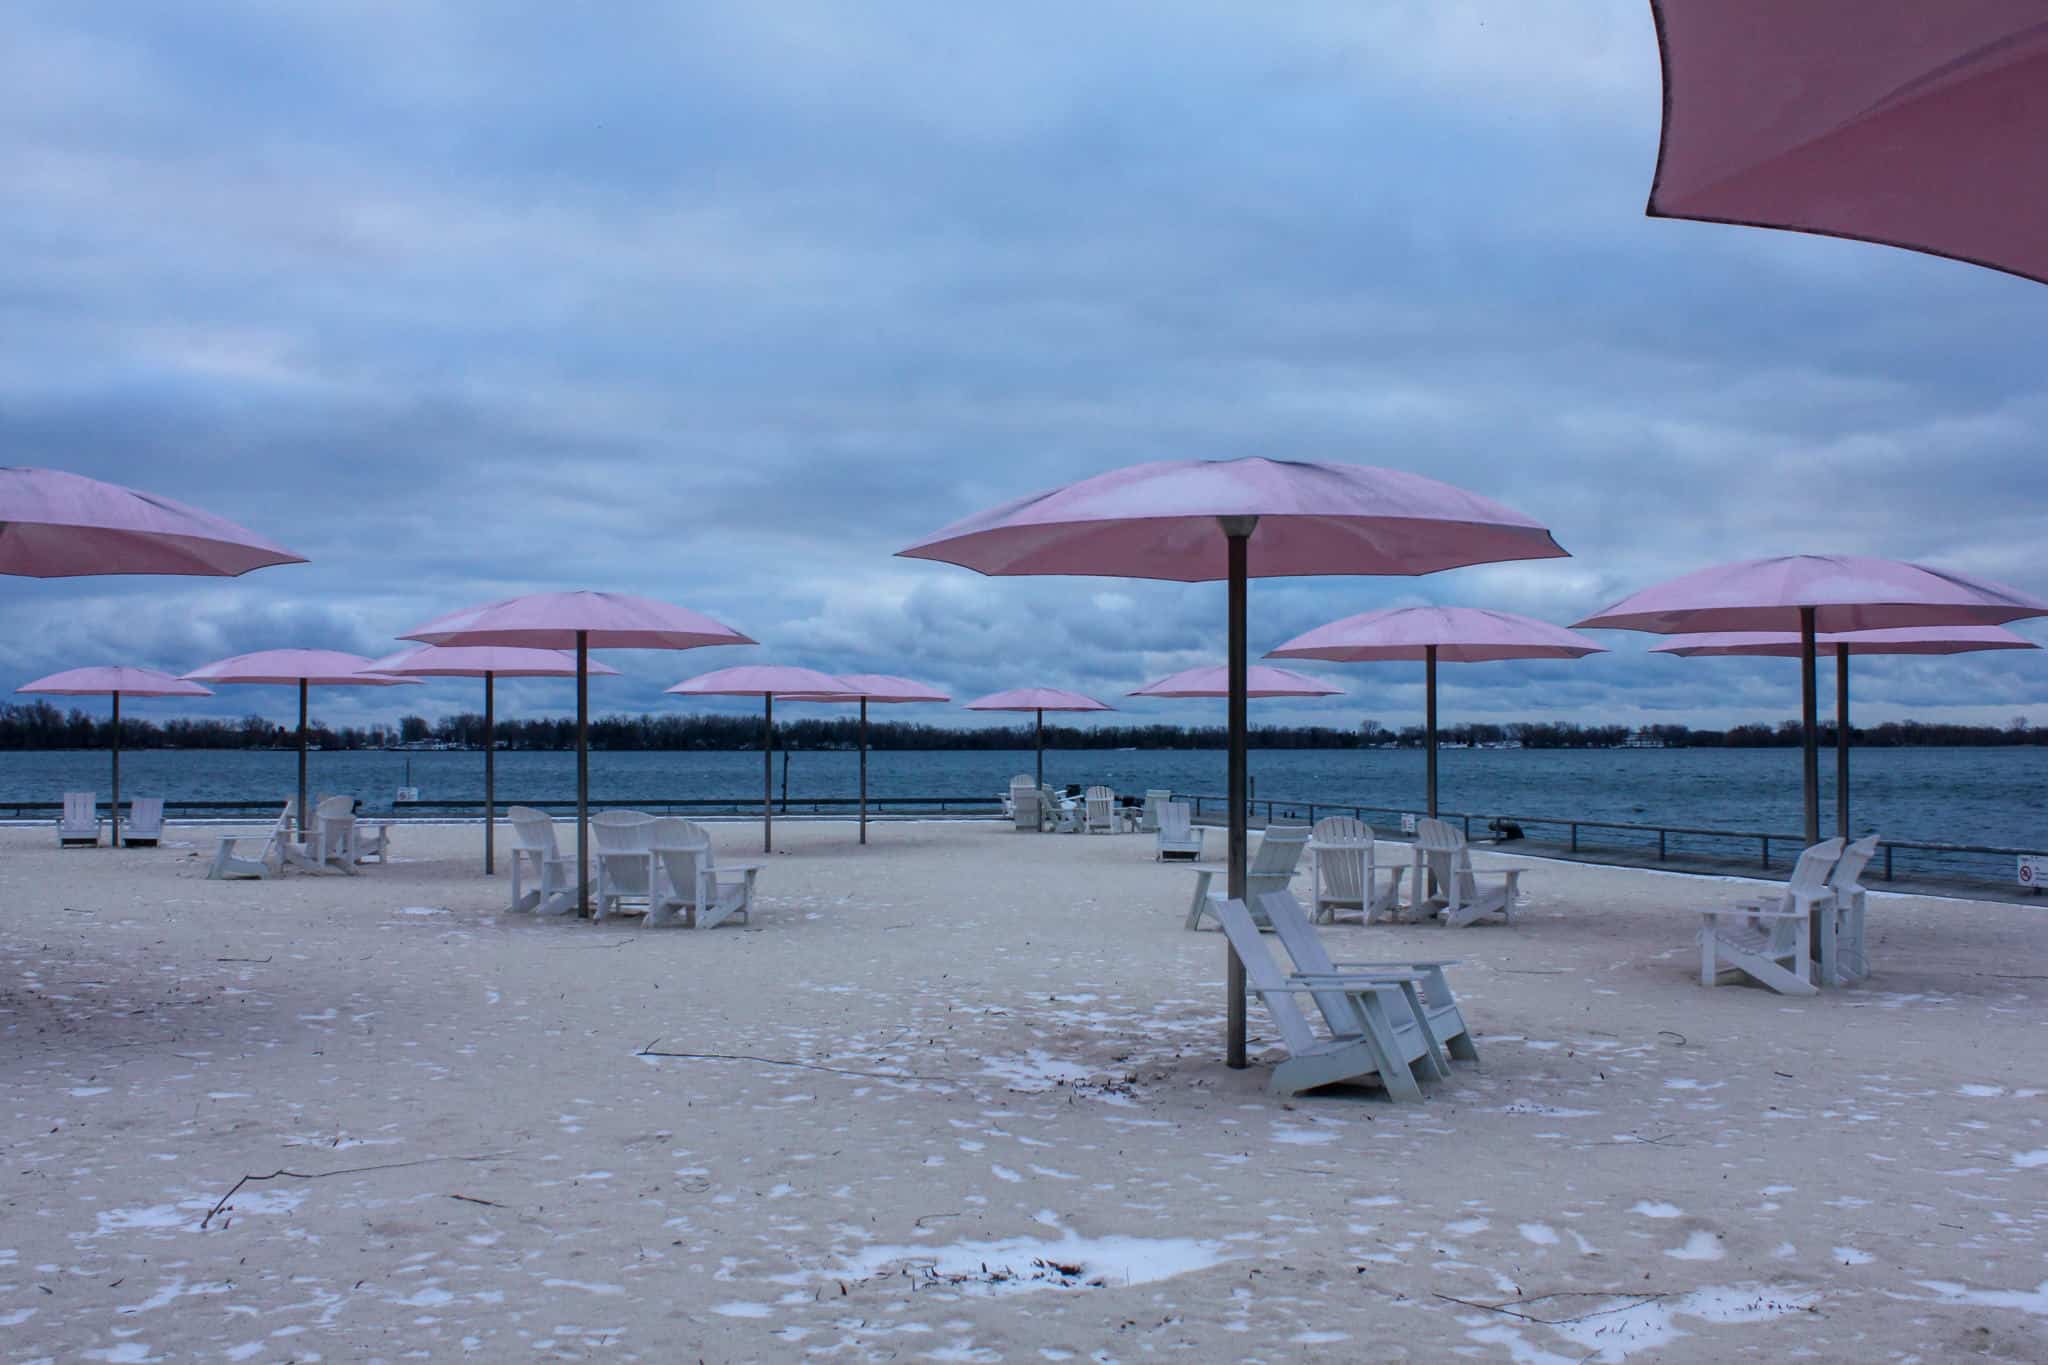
[1214,900,1440,1099]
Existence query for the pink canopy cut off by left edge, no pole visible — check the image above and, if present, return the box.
[0,467,305,579]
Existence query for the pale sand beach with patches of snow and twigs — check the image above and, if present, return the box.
[0,823,2048,1363]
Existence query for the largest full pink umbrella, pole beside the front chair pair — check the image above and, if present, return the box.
[899,456,1565,1066]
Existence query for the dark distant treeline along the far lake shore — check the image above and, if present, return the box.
[0,702,2048,751]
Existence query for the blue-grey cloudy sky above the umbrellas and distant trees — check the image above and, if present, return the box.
[0,0,2048,724]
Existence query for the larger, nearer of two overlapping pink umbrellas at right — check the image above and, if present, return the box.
[1577,555,2048,843]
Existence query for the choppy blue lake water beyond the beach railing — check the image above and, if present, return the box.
[0,747,2048,847]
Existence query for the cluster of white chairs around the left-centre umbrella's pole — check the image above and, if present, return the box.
[506,806,762,929]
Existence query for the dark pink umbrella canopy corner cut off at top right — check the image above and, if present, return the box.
[1649,0,2048,280]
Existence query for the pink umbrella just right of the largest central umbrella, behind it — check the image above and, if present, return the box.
[1266,606,1606,817]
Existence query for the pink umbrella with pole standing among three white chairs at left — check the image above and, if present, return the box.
[397,591,754,917]
